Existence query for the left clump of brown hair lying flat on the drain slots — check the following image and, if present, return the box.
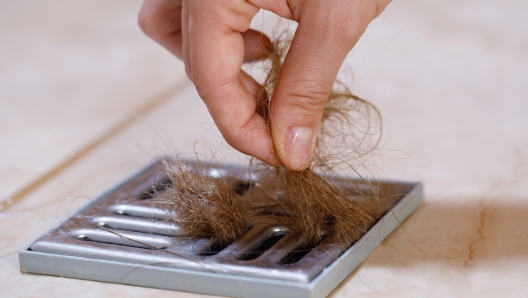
[155,159,249,244]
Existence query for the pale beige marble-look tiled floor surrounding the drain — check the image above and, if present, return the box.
[0,0,528,297]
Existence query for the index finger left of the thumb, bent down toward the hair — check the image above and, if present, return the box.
[183,0,273,163]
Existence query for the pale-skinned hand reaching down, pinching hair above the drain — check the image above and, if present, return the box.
[139,0,390,171]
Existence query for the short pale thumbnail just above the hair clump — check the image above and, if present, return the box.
[287,127,313,170]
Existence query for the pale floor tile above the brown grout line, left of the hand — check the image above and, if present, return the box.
[0,0,185,200]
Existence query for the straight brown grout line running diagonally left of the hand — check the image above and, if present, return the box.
[0,79,191,213]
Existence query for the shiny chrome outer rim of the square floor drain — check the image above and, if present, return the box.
[19,161,423,297]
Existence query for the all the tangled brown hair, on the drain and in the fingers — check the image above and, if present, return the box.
[157,35,384,244]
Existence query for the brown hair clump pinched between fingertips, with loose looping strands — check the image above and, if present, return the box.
[253,36,382,243]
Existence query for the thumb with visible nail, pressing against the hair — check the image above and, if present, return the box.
[271,10,365,171]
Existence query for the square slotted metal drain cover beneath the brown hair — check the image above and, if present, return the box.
[19,162,423,297]
